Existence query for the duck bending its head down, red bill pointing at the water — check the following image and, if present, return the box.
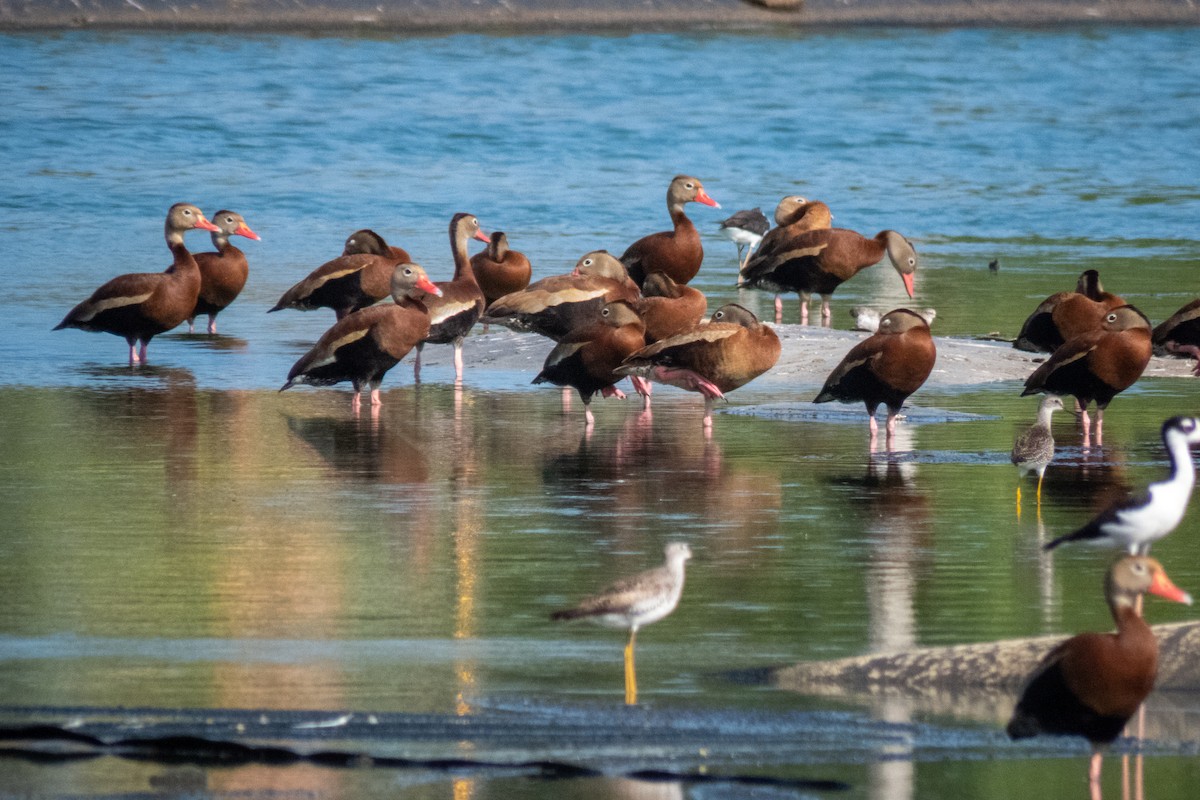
[745,228,917,325]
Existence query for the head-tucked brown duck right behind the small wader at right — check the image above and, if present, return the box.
[1021,306,1152,445]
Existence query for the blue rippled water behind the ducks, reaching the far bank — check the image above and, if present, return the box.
[0,29,1200,386]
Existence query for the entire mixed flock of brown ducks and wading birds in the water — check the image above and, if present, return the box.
[55,175,1200,789]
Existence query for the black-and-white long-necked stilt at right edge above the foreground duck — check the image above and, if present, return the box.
[1045,416,1200,555]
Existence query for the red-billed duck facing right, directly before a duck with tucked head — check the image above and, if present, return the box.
[280,264,440,411]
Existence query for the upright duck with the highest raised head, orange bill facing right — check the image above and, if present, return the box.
[620,175,721,285]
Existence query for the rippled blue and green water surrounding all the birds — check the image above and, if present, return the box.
[0,29,1200,799]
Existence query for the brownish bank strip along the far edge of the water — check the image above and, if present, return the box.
[0,0,1200,35]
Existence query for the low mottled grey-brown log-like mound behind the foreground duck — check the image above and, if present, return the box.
[767,621,1200,694]
